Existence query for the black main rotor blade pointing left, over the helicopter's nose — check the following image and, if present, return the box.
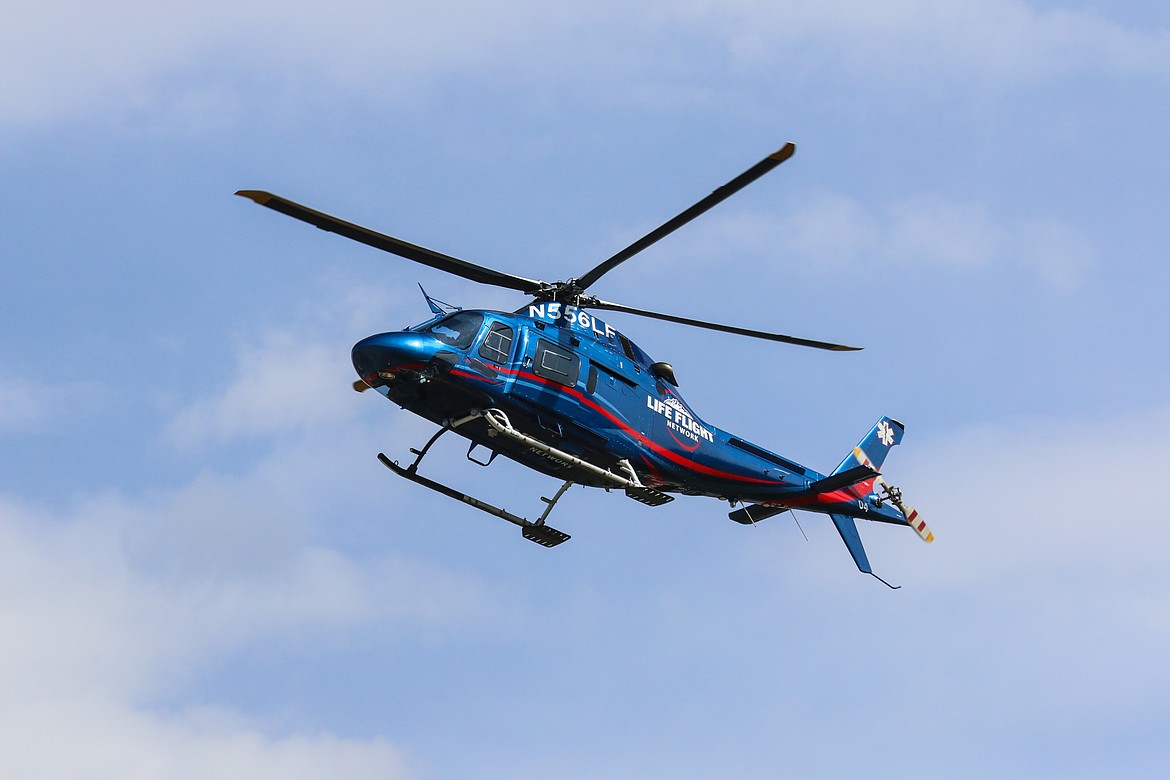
[235,189,541,292]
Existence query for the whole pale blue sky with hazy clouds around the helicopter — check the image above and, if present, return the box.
[0,0,1170,780]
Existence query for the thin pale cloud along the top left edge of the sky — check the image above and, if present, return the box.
[0,0,563,123]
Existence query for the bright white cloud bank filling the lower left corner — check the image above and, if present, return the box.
[0,460,490,779]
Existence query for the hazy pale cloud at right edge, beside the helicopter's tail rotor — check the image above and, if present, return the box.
[899,408,1170,584]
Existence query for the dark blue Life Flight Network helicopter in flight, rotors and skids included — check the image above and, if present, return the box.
[236,143,934,587]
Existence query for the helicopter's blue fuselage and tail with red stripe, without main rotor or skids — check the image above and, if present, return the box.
[353,303,932,582]
